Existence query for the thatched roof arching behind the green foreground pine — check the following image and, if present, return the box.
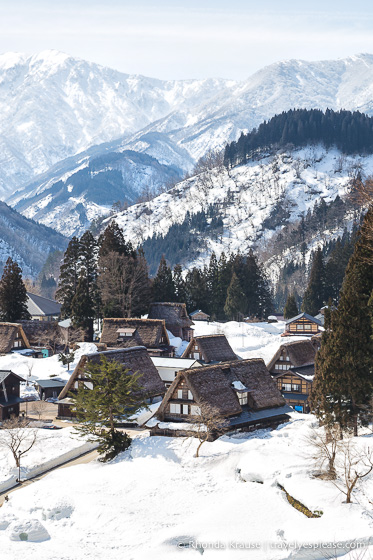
[59,346,166,400]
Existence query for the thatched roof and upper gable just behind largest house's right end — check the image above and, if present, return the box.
[267,340,316,375]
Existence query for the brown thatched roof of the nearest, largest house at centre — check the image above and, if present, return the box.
[157,358,285,418]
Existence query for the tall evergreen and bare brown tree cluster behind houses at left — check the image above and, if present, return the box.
[56,222,150,339]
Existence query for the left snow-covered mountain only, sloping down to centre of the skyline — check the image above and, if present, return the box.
[0,51,229,198]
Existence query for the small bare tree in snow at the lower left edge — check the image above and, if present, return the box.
[0,418,37,467]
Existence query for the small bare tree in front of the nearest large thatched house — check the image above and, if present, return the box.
[190,401,228,457]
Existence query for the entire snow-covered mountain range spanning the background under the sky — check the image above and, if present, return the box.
[0,51,373,206]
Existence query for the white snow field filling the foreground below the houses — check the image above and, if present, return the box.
[0,413,373,560]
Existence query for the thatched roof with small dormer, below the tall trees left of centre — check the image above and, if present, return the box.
[100,318,170,348]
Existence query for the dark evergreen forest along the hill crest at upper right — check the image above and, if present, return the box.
[224,109,373,169]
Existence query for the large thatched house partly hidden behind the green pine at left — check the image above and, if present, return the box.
[58,346,166,417]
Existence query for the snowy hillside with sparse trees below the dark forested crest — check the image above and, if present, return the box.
[106,147,373,276]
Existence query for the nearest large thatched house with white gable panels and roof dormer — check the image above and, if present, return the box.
[152,359,291,435]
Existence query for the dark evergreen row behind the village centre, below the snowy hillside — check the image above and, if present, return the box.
[153,250,273,320]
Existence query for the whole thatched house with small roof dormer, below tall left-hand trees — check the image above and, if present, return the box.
[100,318,174,356]
